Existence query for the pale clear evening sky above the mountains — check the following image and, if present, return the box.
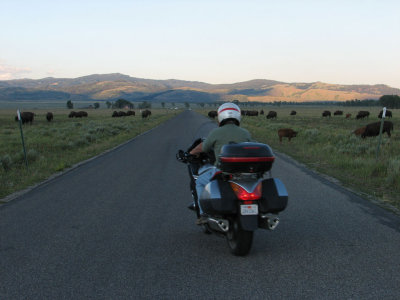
[0,0,400,88]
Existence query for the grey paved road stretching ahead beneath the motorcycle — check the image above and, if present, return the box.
[0,111,400,299]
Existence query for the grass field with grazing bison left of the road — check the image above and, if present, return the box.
[0,109,179,201]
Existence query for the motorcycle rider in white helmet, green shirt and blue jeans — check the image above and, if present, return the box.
[190,103,252,225]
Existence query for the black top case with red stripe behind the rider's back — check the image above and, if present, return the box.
[218,142,275,173]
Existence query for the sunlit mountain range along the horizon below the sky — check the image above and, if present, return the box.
[0,73,400,103]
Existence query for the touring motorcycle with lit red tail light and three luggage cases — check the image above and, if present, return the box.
[176,139,288,256]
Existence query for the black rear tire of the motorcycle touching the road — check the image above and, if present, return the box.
[226,219,253,256]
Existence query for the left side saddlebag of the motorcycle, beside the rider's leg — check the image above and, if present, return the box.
[200,179,238,215]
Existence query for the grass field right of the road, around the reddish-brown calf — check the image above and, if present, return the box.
[236,106,400,208]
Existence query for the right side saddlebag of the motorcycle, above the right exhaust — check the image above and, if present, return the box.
[259,178,288,213]
